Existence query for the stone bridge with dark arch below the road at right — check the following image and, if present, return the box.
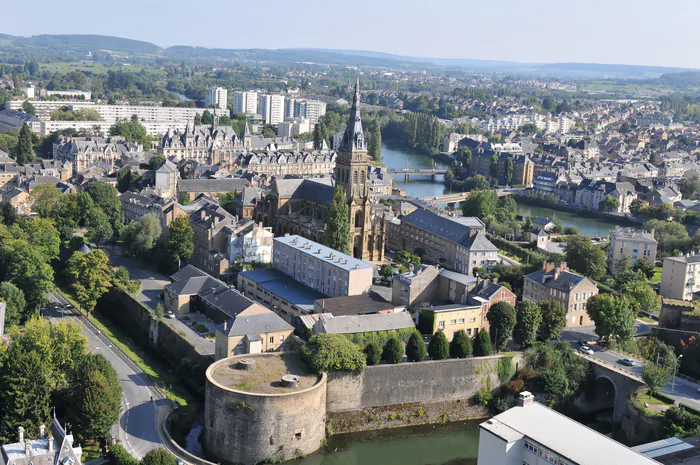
[578,352,645,422]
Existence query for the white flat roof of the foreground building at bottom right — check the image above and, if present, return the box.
[480,402,658,465]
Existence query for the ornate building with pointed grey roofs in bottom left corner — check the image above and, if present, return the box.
[0,411,83,465]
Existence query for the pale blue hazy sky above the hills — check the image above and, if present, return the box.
[0,0,700,68]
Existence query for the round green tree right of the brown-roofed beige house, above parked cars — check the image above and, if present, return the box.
[586,294,636,342]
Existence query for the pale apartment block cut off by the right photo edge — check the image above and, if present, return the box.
[659,252,700,300]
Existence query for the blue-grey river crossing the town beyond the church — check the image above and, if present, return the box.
[382,143,628,236]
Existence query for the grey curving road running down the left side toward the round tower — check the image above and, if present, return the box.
[44,293,170,459]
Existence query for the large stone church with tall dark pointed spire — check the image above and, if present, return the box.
[256,78,390,262]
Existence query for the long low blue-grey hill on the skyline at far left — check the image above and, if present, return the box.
[0,34,163,54]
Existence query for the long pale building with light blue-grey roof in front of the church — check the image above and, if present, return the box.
[272,235,374,297]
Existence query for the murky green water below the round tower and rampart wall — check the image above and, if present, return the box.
[285,422,479,465]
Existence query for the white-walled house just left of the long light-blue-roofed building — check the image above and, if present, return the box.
[227,221,275,264]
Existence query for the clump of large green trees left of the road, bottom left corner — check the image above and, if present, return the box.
[0,318,122,442]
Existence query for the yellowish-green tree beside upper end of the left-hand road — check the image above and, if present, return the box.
[66,249,112,315]
